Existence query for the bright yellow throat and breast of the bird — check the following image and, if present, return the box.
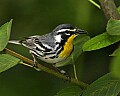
[59,34,77,58]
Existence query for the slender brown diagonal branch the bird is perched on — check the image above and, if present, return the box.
[5,48,88,89]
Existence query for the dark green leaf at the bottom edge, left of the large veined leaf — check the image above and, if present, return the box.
[55,86,82,96]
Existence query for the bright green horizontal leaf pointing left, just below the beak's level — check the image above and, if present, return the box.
[83,32,120,51]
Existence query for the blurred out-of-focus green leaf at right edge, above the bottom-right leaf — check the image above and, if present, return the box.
[111,48,120,78]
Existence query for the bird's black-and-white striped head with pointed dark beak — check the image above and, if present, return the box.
[53,24,87,42]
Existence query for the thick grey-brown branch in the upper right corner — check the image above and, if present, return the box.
[99,0,120,19]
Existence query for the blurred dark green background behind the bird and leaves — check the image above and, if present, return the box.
[0,0,120,96]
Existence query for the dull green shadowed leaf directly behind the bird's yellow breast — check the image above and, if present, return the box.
[56,35,90,67]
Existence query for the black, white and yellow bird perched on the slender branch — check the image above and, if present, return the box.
[9,24,87,74]
